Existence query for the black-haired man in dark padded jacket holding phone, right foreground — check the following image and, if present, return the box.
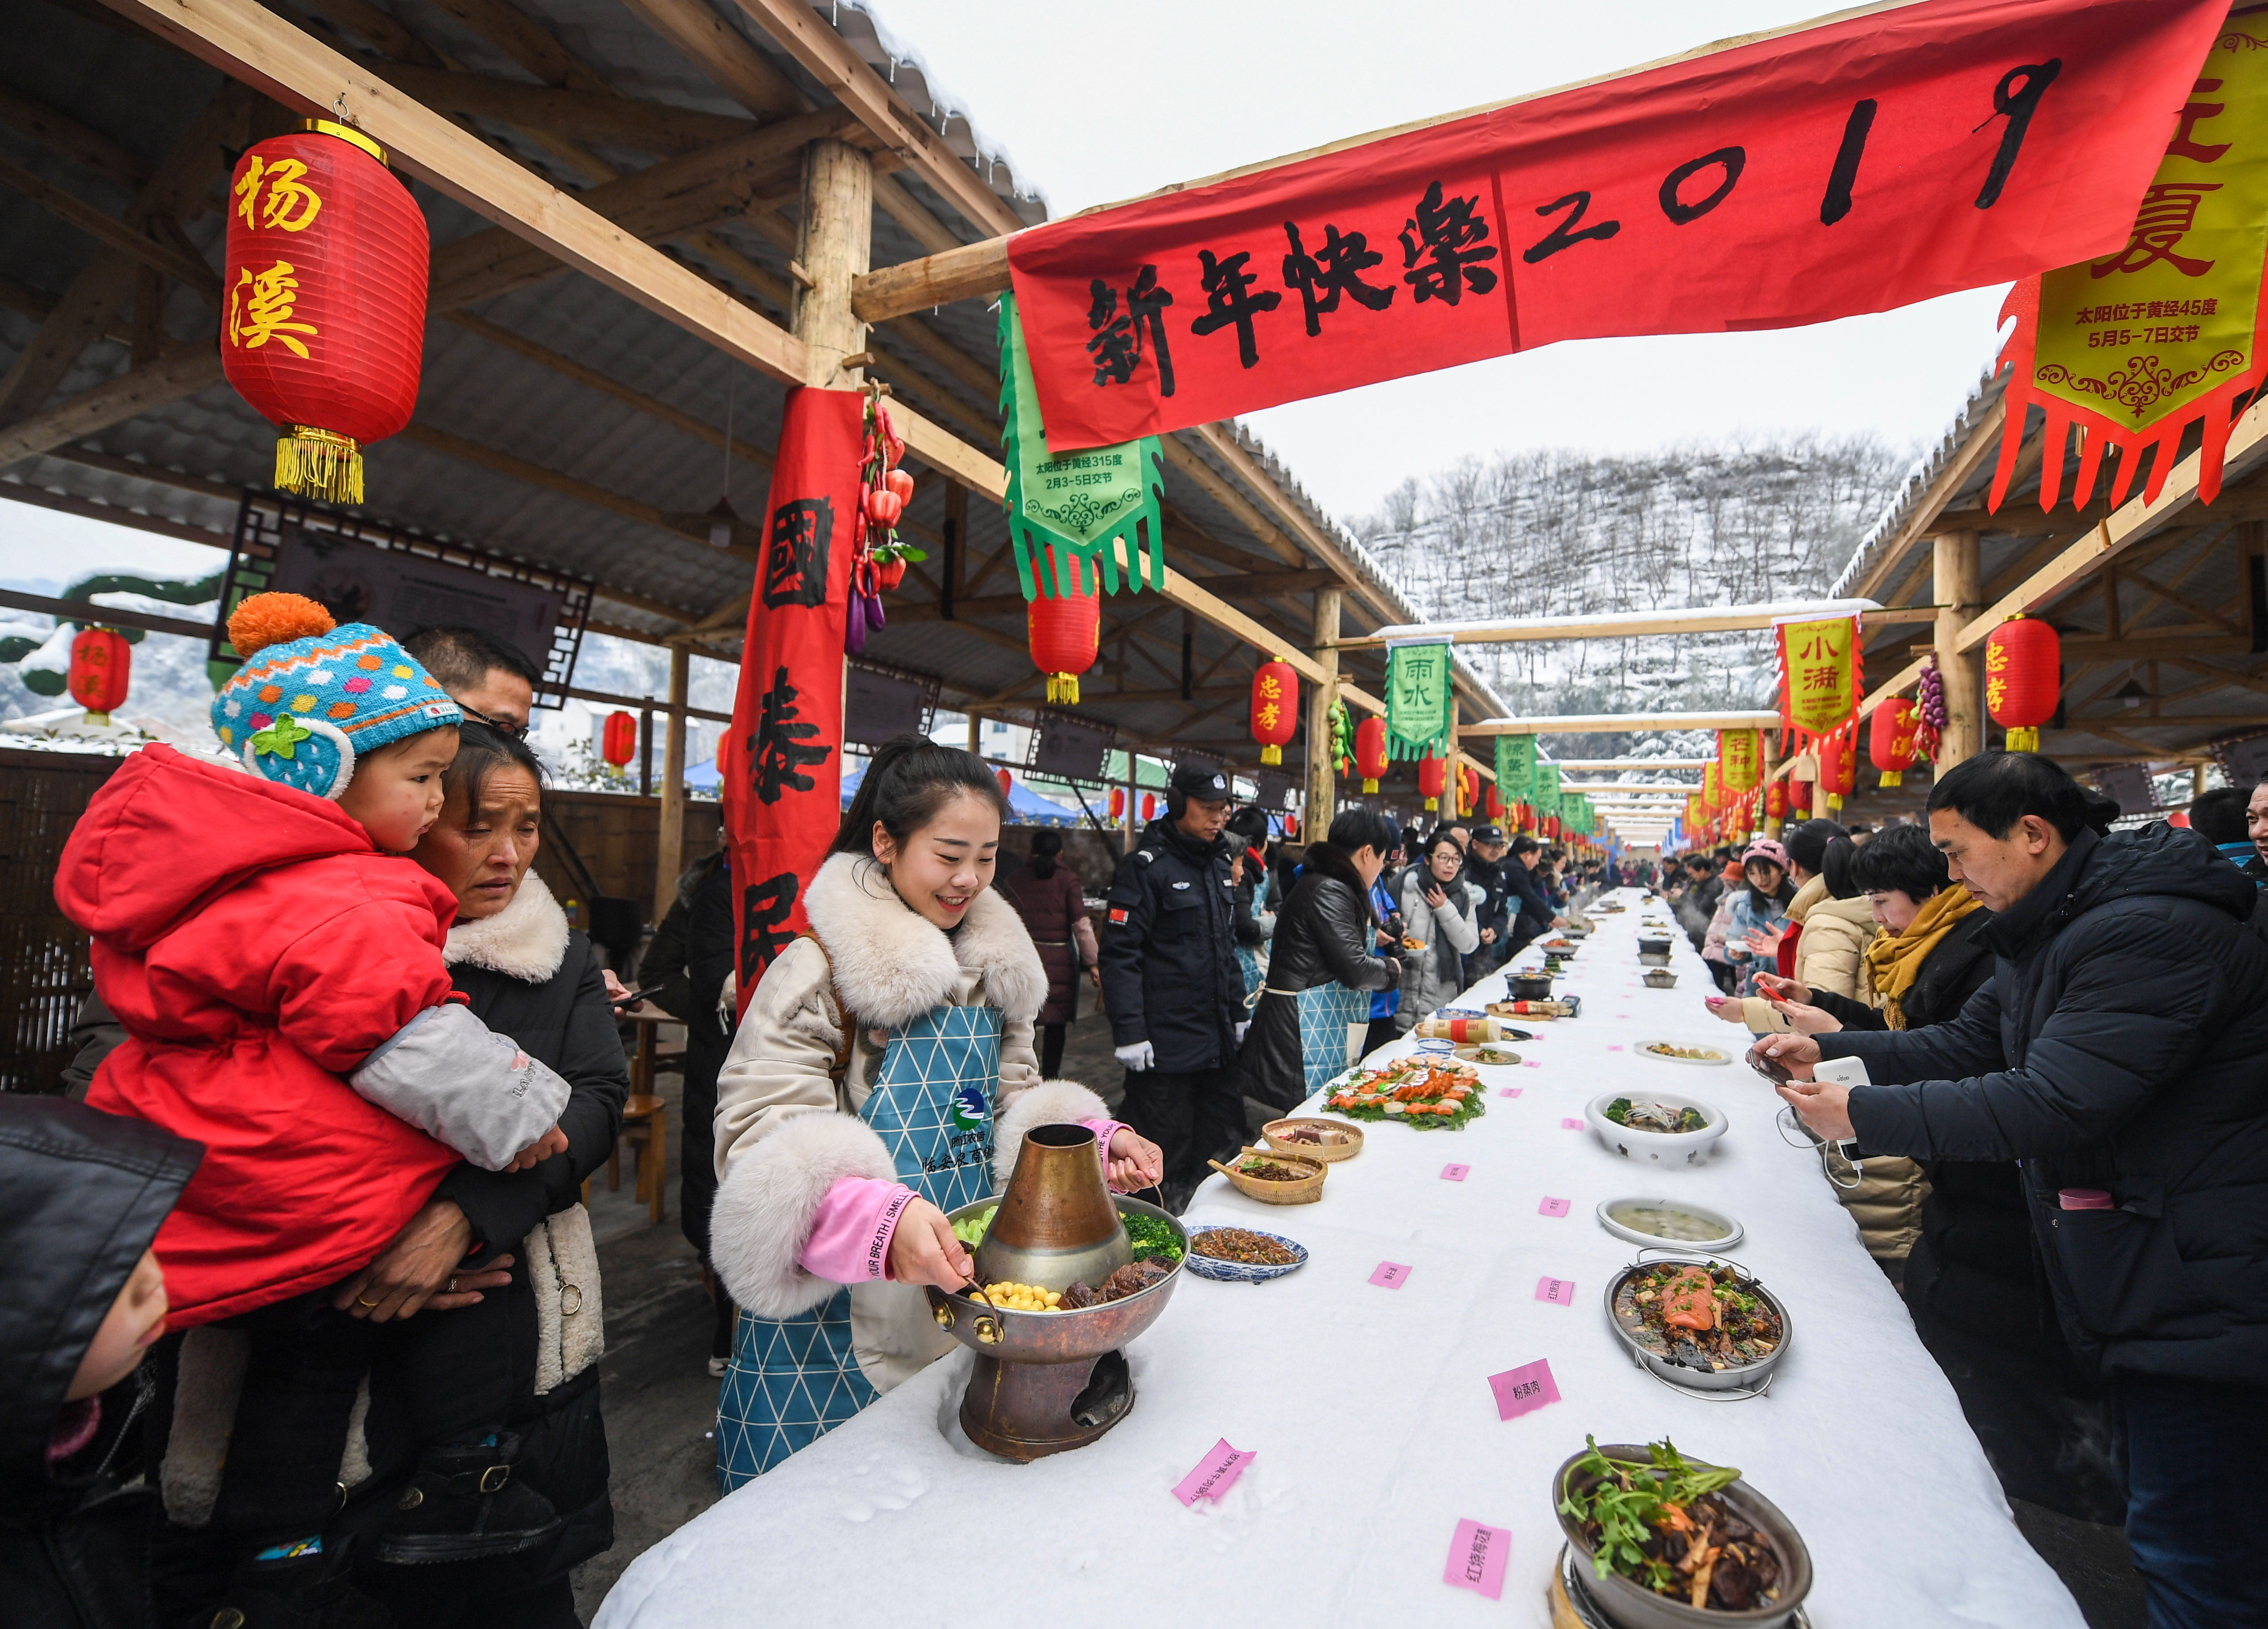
[1751,753,2268,1629]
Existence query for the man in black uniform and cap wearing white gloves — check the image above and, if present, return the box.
[1102,765,1245,1209]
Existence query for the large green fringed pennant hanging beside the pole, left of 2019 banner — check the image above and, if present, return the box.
[1000,293,1166,599]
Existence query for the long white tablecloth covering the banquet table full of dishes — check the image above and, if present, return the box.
[594,889,2082,1629]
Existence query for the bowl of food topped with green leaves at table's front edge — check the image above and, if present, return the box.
[1551,1436,1812,1629]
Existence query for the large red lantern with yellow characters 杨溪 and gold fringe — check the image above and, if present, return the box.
[220,118,433,504]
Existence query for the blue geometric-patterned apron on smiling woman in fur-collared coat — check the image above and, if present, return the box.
[717,1005,1000,1493]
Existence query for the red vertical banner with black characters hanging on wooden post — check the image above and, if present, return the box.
[717,388,864,1010]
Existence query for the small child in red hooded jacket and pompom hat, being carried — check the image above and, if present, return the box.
[54,595,567,1620]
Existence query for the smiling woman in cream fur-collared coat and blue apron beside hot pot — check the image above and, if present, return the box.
[710,737,1159,1491]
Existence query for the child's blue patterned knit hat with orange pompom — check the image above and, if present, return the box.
[213,595,465,799]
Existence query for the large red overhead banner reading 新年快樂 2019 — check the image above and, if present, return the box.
[1007,0,2227,451]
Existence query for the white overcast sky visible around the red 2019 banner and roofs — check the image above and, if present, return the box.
[0,0,2003,579]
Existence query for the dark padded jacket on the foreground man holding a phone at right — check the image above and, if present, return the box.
[1819,824,2268,1384]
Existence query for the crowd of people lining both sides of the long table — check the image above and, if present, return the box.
[0,595,2268,1629]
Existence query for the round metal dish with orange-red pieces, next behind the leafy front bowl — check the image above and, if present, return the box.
[1606,1248,1792,1402]
